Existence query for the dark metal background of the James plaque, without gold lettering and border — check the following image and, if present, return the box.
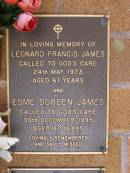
[9,16,108,153]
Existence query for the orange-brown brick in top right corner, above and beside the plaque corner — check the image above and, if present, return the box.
[62,0,130,31]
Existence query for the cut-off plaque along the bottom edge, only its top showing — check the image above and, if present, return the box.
[8,168,105,173]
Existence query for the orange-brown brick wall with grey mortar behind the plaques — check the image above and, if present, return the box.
[0,0,130,173]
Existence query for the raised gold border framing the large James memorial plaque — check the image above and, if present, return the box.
[6,14,110,155]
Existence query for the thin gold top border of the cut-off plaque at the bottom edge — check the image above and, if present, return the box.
[8,168,106,173]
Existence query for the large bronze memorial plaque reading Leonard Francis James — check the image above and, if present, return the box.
[8,15,109,153]
